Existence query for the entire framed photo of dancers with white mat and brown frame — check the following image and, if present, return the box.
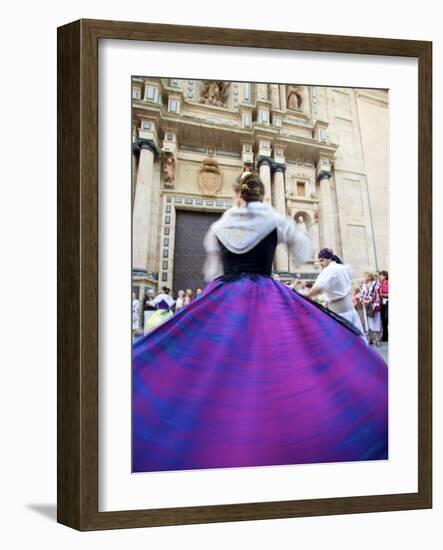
[58,20,432,530]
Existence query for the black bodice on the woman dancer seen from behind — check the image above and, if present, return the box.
[219,229,277,279]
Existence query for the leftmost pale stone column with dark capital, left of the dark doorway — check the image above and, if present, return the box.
[132,139,158,272]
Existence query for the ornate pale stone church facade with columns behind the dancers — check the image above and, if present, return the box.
[132,77,389,297]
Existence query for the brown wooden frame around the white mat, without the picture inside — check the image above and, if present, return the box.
[57,20,432,530]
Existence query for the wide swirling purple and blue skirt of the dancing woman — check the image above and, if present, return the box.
[132,276,388,472]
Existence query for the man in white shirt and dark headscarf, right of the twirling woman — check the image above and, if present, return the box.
[307,248,364,335]
